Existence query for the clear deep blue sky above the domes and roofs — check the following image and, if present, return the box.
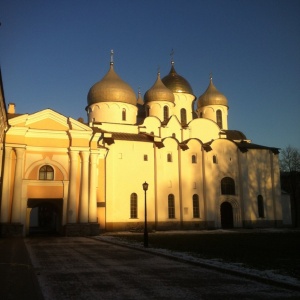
[0,0,300,149]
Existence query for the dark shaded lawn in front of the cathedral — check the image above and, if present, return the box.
[110,230,300,279]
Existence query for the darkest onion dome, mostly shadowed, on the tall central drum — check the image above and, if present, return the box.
[162,61,193,95]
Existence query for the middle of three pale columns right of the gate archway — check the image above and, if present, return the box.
[79,151,89,223]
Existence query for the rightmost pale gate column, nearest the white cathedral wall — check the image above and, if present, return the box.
[89,153,98,223]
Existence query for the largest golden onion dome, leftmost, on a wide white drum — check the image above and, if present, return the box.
[87,62,136,105]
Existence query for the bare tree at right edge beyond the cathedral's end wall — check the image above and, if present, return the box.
[280,146,300,227]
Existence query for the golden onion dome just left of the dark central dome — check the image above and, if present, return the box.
[144,73,175,102]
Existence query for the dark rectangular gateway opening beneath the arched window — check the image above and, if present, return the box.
[27,199,62,235]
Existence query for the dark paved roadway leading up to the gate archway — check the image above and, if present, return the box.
[25,237,300,300]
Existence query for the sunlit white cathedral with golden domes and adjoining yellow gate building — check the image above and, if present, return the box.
[0,57,289,236]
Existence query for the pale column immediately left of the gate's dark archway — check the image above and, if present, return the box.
[11,148,25,223]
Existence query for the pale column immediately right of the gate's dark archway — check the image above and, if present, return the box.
[67,150,78,223]
